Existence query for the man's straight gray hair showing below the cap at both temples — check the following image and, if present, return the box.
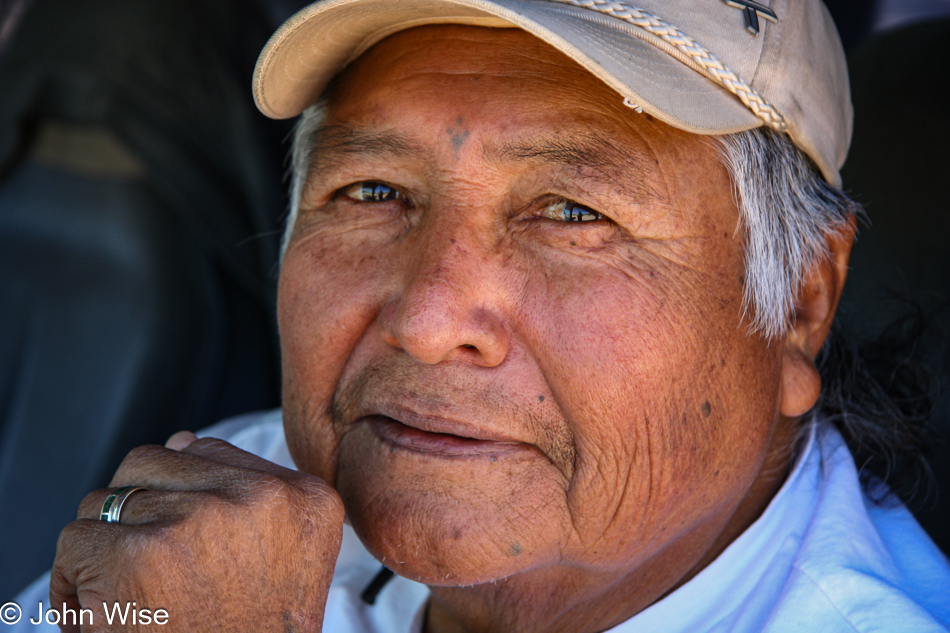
[281,100,861,339]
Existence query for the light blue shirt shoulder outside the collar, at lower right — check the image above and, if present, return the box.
[767,426,950,632]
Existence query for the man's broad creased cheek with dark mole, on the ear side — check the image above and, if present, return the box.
[526,241,780,558]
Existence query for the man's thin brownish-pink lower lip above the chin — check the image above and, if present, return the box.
[365,415,527,457]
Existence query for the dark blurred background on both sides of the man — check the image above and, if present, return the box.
[0,0,950,602]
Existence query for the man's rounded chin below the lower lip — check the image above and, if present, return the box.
[336,430,563,586]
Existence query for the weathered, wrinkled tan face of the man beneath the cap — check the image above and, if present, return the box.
[279,26,787,585]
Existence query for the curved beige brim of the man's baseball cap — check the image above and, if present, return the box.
[254,0,762,134]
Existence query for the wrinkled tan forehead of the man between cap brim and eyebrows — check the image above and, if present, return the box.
[323,25,709,188]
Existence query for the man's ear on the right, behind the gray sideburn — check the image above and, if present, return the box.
[779,216,855,418]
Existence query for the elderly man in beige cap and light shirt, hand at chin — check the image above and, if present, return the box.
[9,0,950,633]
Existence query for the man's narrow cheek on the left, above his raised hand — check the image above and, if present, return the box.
[277,231,386,484]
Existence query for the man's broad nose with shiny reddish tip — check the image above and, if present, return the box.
[379,234,509,367]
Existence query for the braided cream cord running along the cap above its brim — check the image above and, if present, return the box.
[550,0,788,132]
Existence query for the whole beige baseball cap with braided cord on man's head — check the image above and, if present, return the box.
[254,0,852,186]
